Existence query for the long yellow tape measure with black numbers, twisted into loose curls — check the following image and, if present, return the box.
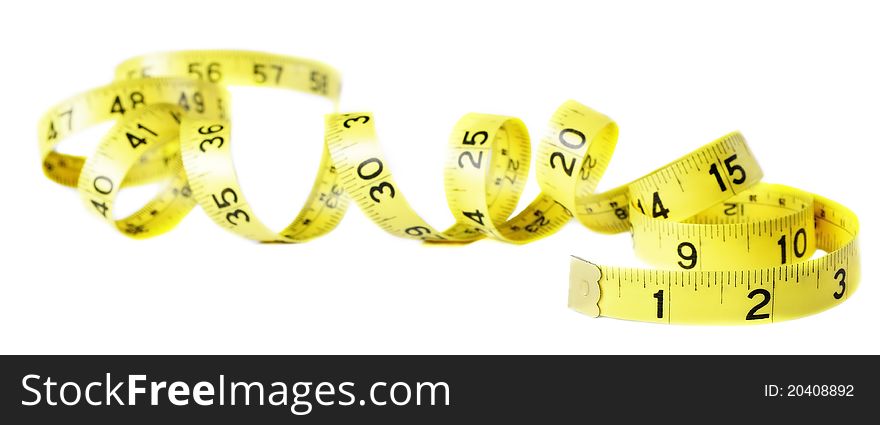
[39,51,859,324]
